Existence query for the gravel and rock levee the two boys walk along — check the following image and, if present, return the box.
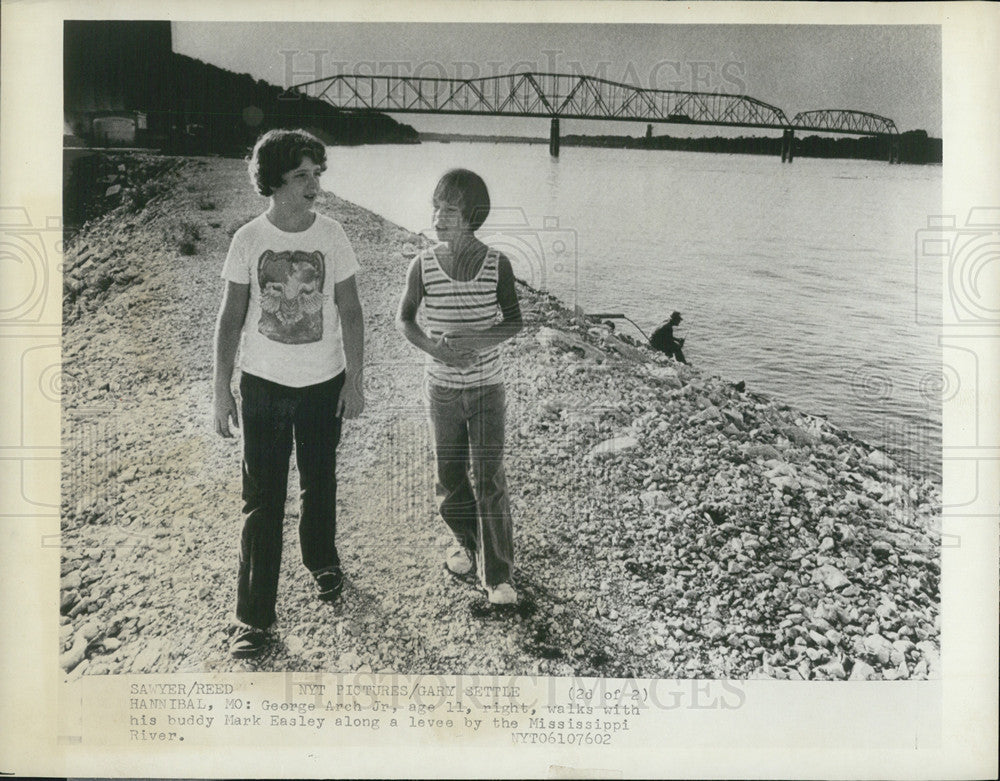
[60,158,940,679]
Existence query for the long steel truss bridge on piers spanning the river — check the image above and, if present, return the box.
[289,73,899,162]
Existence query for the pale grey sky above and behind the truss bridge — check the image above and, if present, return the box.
[173,22,941,137]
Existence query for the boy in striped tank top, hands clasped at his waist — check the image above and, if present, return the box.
[396,168,522,604]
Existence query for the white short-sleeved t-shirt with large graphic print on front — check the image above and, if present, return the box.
[222,214,358,388]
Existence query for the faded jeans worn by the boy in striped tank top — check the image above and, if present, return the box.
[427,384,514,587]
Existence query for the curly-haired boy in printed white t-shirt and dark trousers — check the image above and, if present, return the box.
[214,130,364,658]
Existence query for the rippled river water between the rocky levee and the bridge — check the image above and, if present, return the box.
[323,143,942,476]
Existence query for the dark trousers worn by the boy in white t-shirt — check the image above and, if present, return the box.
[236,372,344,629]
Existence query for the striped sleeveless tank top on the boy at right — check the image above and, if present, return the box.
[420,248,503,388]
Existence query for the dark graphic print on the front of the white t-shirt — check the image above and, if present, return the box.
[257,250,326,344]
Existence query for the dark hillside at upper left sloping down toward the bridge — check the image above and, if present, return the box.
[63,21,419,155]
